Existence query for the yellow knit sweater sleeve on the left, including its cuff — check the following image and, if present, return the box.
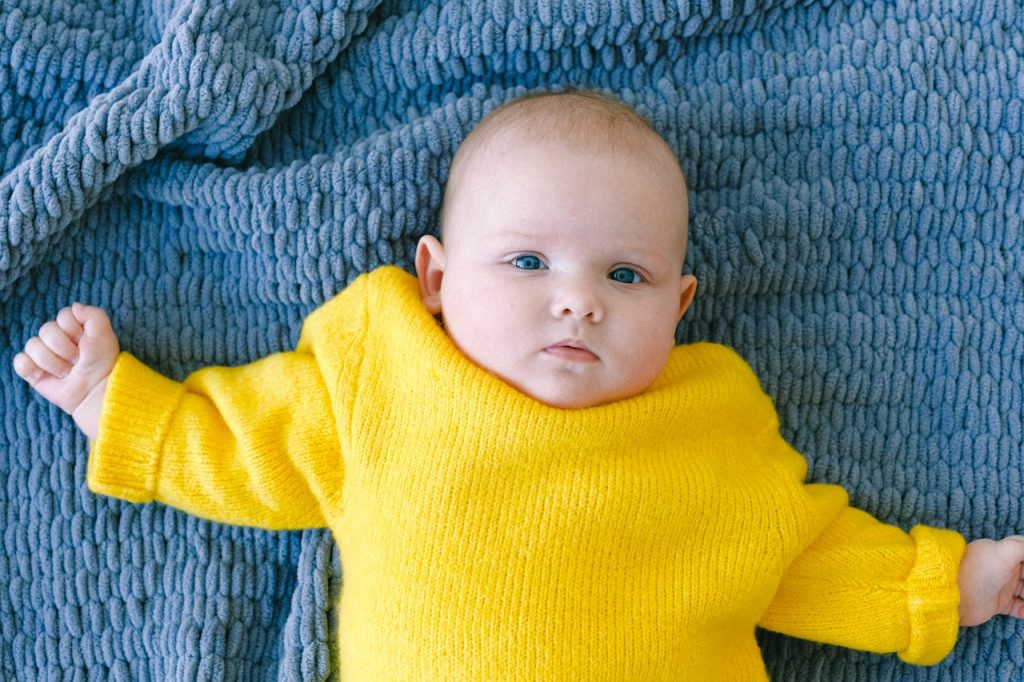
[87,274,365,529]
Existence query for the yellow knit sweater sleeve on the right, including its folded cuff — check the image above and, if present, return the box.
[760,430,965,665]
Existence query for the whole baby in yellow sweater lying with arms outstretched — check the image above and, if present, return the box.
[14,93,1024,680]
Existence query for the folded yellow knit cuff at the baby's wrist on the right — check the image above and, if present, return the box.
[899,525,966,666]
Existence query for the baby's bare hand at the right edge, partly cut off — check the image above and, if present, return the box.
[957,536,1024,626]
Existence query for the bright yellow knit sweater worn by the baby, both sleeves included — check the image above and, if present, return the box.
[88,267,964,681]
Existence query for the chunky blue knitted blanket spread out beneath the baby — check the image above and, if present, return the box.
[0,0,1024,682]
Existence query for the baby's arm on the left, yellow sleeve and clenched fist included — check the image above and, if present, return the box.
[14,304,347,529]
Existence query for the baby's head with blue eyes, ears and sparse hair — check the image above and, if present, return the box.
[416,92,696,408]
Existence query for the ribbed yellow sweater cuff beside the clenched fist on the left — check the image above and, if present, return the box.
[86,352,184,502]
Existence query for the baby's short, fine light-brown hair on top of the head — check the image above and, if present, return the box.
[440,89,682,236]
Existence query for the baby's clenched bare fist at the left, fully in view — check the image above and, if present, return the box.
[14,303,120,439]
